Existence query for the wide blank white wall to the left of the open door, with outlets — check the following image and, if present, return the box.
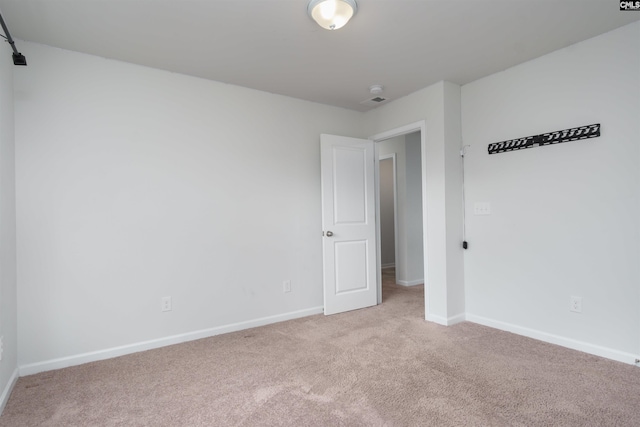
[15,43,363,374]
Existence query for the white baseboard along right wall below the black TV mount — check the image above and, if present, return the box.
[466,314,639,365]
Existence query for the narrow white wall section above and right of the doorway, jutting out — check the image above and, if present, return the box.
[364,82,464,325]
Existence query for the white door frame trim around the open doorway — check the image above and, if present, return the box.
[369,120,429,319]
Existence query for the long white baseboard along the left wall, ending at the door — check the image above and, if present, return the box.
[16,307,324,378]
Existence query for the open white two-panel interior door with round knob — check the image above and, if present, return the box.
[320,135,378,314]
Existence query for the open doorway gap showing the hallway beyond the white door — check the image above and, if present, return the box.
[376,130,425,308]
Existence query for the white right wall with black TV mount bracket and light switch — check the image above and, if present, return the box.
[462,23,640,362]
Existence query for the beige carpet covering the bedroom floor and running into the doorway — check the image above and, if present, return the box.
[0,270,640,426]
